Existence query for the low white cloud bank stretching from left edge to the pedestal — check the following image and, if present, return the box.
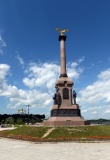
[0,64,52,108]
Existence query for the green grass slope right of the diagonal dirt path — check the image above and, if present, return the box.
[47,125,110,138]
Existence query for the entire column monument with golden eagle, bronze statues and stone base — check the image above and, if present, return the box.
[44,28,89,126]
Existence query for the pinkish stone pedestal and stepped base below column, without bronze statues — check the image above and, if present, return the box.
[44,77,90,126]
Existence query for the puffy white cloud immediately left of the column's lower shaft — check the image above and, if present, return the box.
[23,63,59,89]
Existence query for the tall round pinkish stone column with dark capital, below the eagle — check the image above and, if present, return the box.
[59,35,67,77]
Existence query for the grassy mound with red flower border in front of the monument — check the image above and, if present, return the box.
[0,125,110,141]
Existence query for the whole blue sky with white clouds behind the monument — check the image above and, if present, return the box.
[0,0,110,119]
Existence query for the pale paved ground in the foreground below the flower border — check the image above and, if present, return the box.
[0,138,110,160]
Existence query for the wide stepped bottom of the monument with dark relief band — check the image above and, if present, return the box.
[44,104,90,126]
